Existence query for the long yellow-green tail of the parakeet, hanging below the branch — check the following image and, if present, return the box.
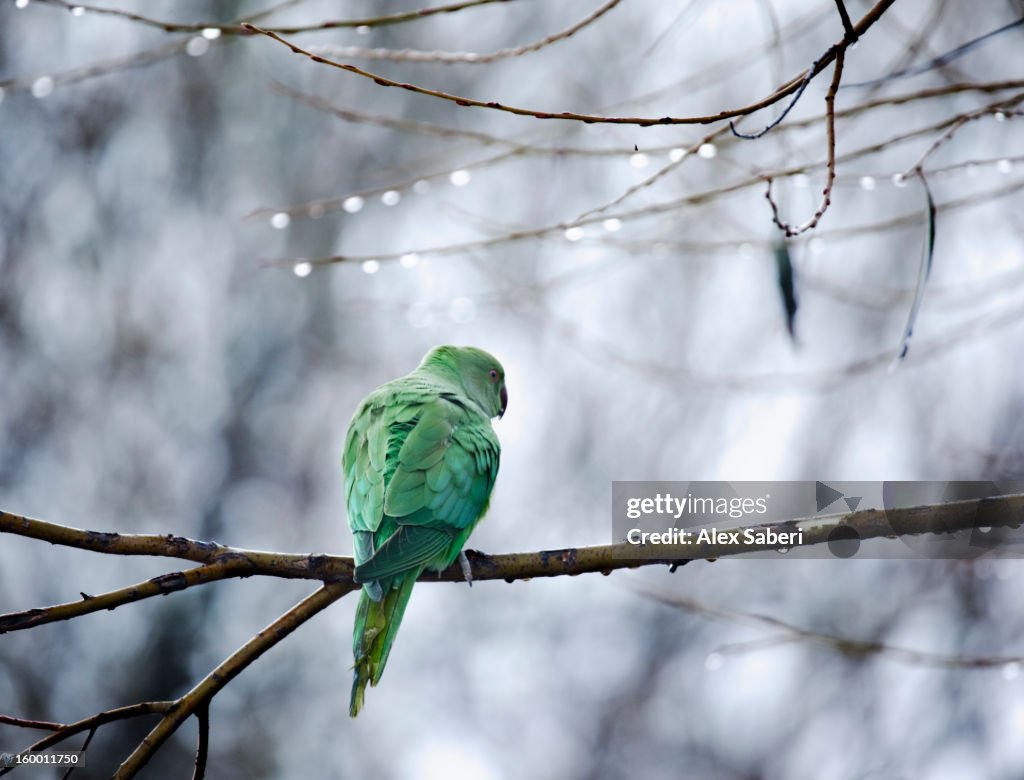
[348,569,421,718]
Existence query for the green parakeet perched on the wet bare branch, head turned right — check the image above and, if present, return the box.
[342,346,508,718]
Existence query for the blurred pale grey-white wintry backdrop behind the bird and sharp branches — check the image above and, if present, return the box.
[0,0,1024,780]
